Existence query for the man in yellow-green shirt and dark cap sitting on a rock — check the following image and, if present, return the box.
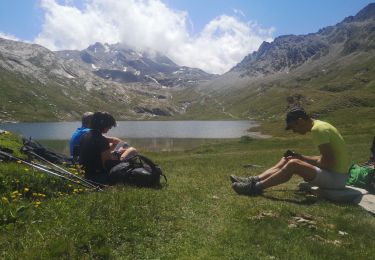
[230,108,349,196]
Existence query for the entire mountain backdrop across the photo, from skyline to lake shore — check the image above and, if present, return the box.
[0,4,375,127]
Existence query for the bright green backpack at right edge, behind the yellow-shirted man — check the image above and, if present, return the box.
[346,164,375,192]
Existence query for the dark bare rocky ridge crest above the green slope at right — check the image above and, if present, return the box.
[230,3,375,77]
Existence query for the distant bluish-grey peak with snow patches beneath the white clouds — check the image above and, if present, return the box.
[56,42,219,87]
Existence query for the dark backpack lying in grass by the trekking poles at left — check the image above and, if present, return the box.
[21,138,73,164]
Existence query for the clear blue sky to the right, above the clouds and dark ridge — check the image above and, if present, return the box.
[164,0,374,36]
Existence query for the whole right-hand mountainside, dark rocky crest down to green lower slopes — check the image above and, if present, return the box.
[182,3,375,127]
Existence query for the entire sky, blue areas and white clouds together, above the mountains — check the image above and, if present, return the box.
[0,0,372,74]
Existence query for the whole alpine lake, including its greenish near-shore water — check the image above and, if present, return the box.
[0,120,265,154]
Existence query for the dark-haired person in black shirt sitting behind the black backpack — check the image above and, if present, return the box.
[79,112,137,184]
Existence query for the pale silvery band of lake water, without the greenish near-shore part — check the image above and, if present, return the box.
[0,120,256,140]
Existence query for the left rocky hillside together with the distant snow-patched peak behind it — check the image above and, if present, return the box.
[0,38,217,121]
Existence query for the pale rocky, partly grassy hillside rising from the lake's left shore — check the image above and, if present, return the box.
[0,39,184,121]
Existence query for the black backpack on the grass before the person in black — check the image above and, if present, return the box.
[109,154,167,187]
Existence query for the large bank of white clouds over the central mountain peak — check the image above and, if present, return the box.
[35,0,273,73]
